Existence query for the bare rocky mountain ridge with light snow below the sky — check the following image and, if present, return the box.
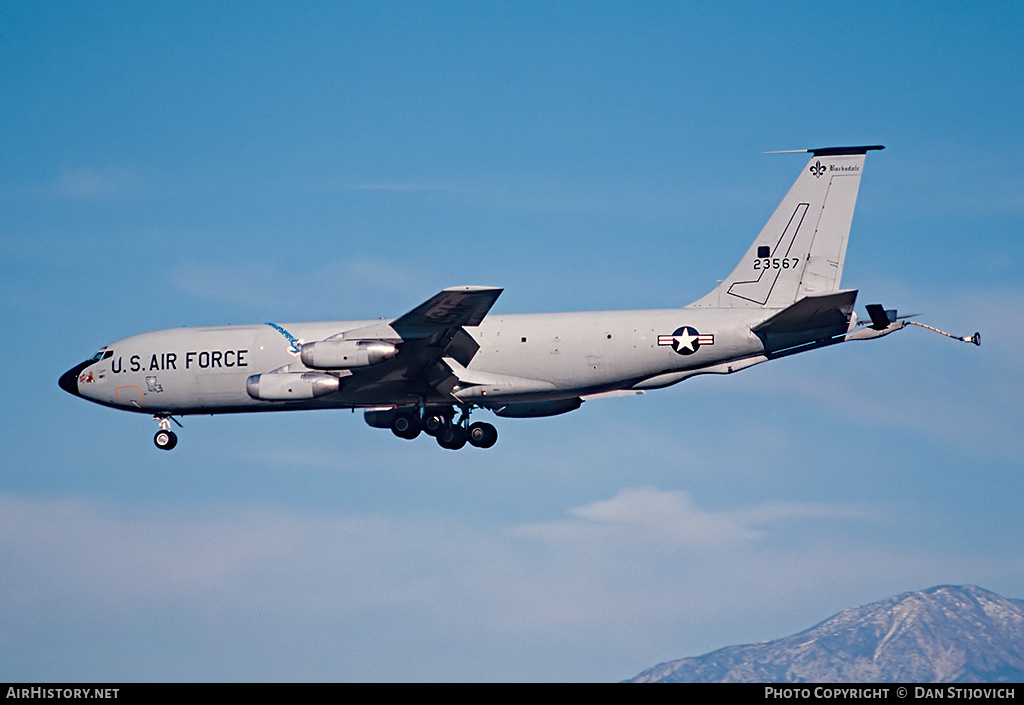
[628,585,1024,682]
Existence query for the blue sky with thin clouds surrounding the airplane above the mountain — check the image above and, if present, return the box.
[0,2,1024,681]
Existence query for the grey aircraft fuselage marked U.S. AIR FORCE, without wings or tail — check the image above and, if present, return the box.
[62,308,763,415]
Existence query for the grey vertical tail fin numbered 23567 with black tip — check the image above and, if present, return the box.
[687,146,885,308]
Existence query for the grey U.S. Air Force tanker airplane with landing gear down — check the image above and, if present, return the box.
[58,146,981,450]
